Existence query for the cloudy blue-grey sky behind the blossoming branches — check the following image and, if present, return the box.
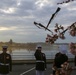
[0,0,76,43]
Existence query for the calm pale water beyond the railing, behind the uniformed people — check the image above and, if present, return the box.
[0,45,74,60]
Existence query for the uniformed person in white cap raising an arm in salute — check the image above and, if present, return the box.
[34,46,46,75]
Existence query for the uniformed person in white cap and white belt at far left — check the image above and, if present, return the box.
[0,46,12,75]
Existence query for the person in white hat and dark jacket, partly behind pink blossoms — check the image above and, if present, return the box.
[53,46,68,75]
